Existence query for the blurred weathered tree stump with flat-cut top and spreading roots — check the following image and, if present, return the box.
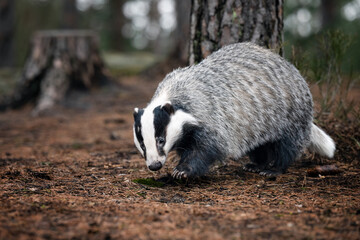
[2,30,107,115]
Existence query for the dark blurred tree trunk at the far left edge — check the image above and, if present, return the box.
[0,0,15,67]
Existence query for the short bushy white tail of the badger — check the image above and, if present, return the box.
[309,123,335,158]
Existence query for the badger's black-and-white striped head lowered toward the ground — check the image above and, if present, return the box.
[133,101,196,171]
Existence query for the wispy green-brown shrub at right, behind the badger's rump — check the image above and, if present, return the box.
[291,30,359,120]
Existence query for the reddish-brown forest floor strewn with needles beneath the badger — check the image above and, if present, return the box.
[0,77,360,239]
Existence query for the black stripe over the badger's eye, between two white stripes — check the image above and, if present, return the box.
[153,106,170,156]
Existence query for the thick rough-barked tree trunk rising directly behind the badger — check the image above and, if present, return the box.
[189,0,283,64]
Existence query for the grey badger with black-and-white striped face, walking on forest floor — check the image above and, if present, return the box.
[133,43,335,179]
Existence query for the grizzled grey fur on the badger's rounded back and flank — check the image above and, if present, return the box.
[152,43,312,158]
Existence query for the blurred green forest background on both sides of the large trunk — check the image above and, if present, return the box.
[0,0,360,116]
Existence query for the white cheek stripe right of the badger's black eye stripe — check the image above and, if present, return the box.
[164,110,198,155]
